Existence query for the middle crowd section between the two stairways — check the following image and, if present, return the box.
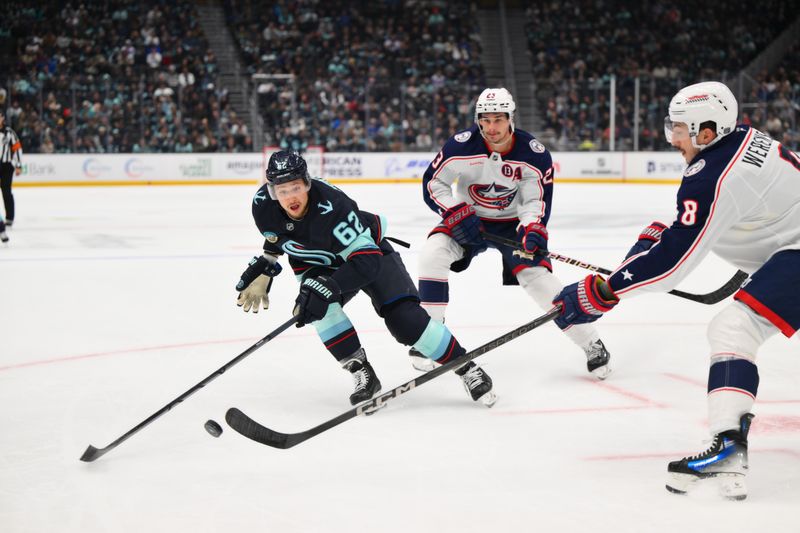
[225,0,485,151]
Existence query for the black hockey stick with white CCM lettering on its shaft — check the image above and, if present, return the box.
[225,305,561,450]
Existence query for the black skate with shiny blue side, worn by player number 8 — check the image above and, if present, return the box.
[667,413,754,500]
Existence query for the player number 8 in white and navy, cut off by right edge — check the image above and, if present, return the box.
[554,82,800,499]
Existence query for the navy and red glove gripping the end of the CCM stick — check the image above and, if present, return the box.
[553,274,619,329]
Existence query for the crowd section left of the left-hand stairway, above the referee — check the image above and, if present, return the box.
[0,0,252,153]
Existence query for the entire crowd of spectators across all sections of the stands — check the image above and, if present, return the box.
[0,0,800,153]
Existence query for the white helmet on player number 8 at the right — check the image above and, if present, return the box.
[664,81,739,150]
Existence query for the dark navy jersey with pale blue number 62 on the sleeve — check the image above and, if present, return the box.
[253,179,385,289]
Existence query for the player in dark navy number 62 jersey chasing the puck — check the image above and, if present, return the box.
[231,151,496,407]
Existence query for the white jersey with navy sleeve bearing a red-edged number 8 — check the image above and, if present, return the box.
[608,125,800,296]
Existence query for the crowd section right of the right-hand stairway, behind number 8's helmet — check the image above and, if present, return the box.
[526,0,800,150]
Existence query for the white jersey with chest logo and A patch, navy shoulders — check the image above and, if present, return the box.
[422,126,553,225]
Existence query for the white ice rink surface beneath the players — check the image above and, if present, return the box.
[0,183,800,533]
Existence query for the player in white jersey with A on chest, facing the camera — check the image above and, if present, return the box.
[409,88,610,379]
